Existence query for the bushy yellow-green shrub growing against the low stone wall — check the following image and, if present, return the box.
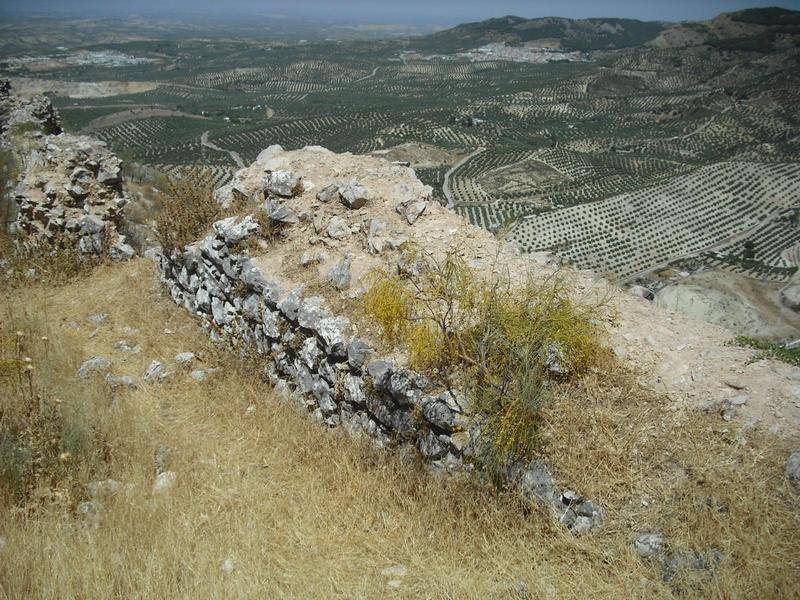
[363,250,607,457]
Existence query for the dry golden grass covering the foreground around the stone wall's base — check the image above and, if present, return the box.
[0,260,800,599]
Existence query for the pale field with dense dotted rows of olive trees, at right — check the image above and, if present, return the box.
[512,162,800,279]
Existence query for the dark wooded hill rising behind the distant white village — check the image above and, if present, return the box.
[415,15,664,52]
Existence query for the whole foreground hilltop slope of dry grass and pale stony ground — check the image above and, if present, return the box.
[0,85,800,600]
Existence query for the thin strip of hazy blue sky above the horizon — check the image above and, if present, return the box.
[0,0,800,24]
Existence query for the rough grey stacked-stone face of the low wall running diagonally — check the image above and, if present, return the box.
[159,216,602,532]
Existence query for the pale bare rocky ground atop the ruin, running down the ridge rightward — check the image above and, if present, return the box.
[214,146,800,435]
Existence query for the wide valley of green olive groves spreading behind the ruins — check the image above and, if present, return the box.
[7,34,800,280]
